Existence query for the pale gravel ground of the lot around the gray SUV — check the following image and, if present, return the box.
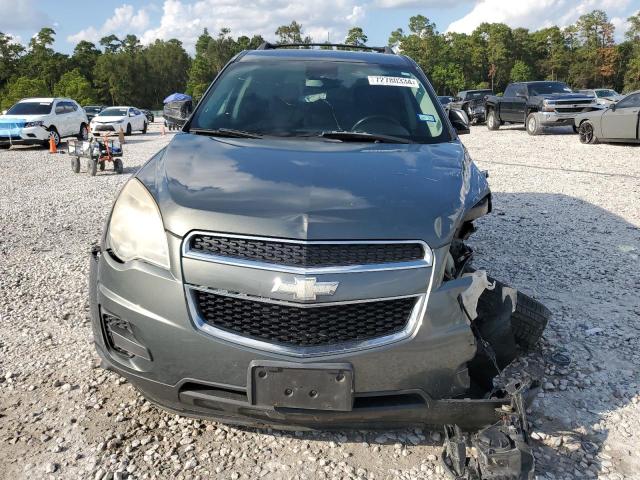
[0,124,640,480]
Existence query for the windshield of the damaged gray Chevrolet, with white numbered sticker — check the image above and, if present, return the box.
[190,60,449,143]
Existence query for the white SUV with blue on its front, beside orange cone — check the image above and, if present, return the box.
[0,98,89,149]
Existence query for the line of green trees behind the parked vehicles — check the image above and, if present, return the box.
[0,10,640,109]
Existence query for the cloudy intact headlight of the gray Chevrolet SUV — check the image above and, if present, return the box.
[107,178,169,269]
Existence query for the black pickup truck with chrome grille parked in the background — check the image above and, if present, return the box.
[486,81,600,135]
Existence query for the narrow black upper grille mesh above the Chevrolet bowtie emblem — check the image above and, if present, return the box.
[189,234,425,268]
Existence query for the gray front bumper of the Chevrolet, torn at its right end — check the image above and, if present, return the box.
[90,240,524,430]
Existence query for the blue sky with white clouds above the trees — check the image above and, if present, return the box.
[0,0,640,53]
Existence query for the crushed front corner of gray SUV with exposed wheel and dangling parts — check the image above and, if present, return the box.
[442,198,551,480]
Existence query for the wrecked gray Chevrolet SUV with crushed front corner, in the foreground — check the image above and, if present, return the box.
[90,44,548,473]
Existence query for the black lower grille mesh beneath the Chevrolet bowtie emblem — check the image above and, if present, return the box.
[194,290,416,347]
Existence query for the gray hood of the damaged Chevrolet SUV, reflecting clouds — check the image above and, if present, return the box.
[138,134,488,247]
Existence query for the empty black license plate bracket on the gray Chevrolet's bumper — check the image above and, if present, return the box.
[248,360,353,411]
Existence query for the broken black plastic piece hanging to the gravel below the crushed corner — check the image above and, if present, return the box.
[442,381,535,480]
